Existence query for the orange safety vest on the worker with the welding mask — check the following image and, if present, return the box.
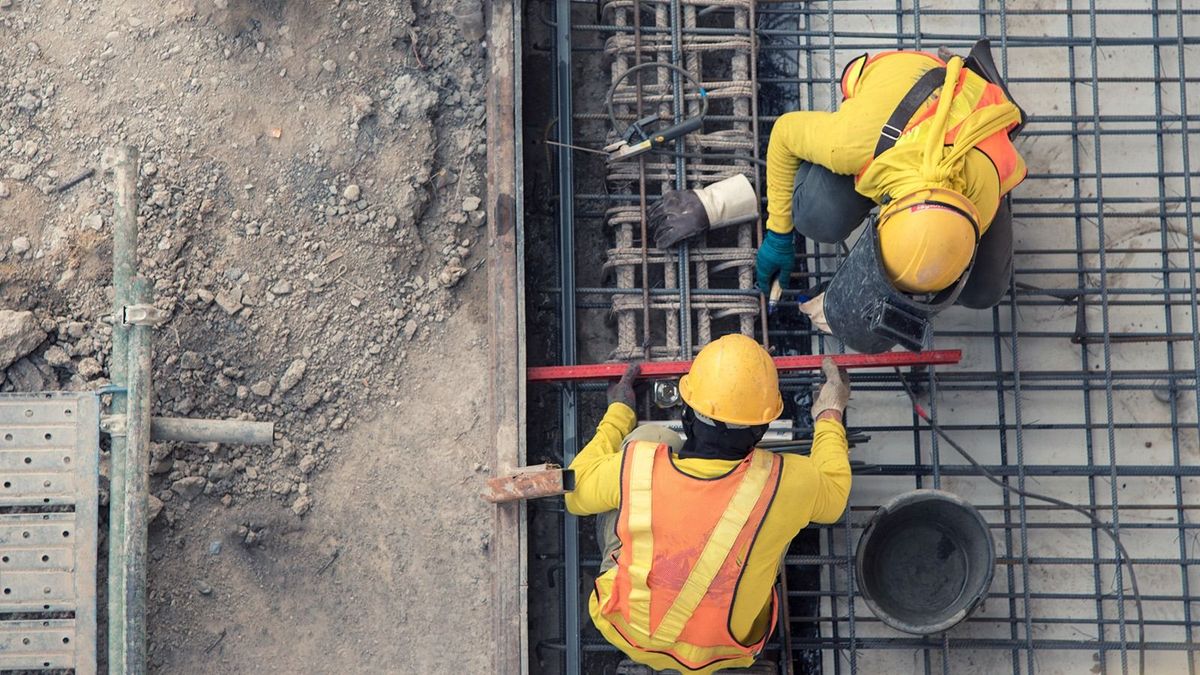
[841,52,1027,197]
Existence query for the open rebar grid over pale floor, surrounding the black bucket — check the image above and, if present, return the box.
[758,0,1200,673]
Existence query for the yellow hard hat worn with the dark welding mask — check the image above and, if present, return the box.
[878,187,979,293]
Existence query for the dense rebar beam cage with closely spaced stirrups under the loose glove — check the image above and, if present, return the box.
[597,0,761,359]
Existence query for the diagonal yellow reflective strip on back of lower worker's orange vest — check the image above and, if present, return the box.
[652,450,774,643]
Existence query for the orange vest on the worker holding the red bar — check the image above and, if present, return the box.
[601,441,784,670]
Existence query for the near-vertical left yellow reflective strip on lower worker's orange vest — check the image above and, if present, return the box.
[622,442,658,635]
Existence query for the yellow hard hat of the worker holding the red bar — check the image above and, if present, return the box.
[679,334,784,426]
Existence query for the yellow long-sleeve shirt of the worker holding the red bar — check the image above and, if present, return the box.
[565,404,851,674]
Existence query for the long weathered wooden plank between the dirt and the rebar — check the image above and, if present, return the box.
[485,0,529,675]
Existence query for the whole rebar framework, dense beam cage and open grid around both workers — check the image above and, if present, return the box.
[530,0,1200,674]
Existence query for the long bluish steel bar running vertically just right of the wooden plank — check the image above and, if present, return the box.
[554,0,582,675]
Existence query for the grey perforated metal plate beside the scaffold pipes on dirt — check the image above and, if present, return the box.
[0,394,100,675]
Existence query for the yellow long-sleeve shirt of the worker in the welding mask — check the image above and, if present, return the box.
[767,52,1001,234]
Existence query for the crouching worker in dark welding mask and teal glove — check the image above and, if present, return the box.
[653,40,1026,352]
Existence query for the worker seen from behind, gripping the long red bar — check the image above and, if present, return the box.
[566,335,850,674]
